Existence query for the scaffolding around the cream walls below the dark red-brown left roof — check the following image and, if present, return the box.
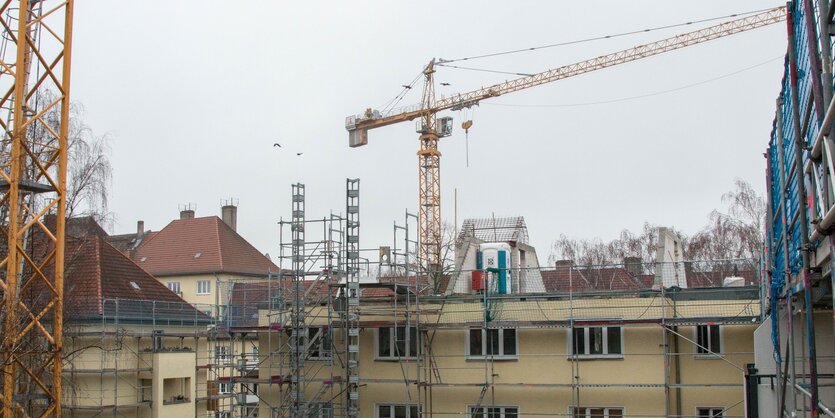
[63,298,237,417]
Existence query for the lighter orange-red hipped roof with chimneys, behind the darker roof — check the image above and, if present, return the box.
[136,216,278,277]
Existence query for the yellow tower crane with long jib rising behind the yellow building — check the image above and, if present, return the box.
[345,7,786,272]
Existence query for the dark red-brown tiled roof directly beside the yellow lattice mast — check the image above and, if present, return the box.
[64,235,199,318]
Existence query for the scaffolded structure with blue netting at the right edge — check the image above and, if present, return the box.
[756,0,835,417]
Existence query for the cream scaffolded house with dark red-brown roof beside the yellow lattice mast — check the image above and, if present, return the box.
[54,235,232,417]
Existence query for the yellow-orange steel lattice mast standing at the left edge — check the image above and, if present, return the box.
[0,0,74,418]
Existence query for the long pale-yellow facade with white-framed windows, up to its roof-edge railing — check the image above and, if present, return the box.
[250,262,760,418]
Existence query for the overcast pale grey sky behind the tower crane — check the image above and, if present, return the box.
[72,0,786,262]
